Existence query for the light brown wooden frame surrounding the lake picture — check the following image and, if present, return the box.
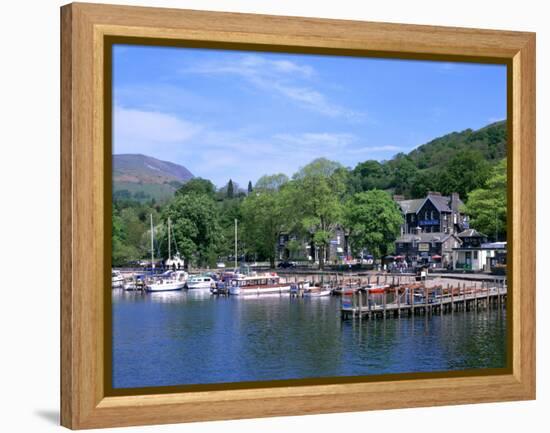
[61,3,535,429]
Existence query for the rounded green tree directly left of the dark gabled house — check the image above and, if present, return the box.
[344,190,403,257]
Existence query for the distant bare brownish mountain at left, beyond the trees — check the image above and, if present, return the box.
[113,154,193,201]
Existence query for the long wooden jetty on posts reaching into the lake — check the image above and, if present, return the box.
[341,280,507,319]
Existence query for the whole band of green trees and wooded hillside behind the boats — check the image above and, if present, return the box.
[112,123,507,267]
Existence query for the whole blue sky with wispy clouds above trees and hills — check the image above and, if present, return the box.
[113,45,506,187]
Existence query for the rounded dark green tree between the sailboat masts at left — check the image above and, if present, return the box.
[163,193,223,266]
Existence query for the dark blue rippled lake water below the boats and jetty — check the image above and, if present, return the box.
[113,290,506,388]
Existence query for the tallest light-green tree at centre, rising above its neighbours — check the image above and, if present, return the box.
[292,158,347,269]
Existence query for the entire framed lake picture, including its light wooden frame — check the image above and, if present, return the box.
[61,4,535,429]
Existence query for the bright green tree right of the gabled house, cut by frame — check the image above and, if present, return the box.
[463,159,507,241]
